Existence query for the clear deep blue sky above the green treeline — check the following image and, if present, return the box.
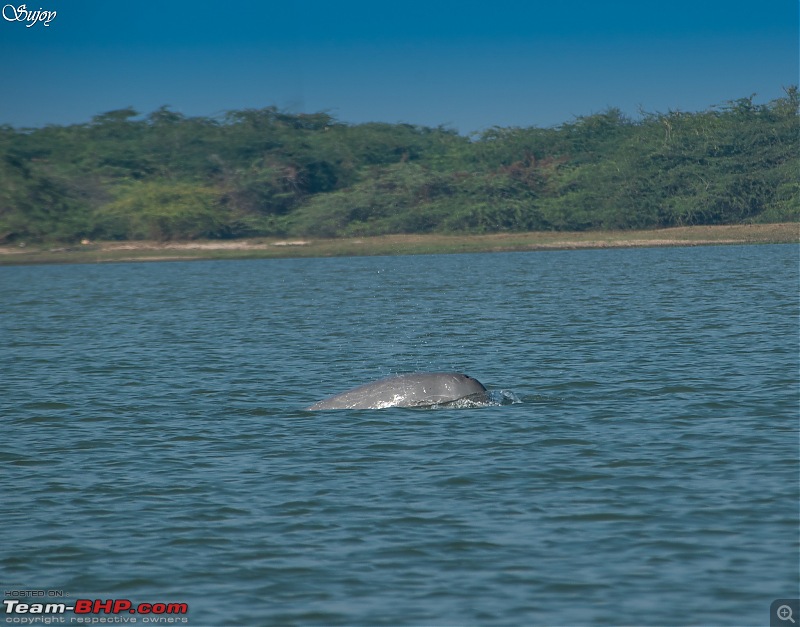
[0,0,800,133]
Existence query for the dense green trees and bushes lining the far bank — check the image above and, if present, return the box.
[0,87,800,242]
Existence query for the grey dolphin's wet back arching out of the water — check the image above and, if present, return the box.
[305,372,487,411]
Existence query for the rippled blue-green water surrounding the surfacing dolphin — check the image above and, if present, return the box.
[0,245,800,626]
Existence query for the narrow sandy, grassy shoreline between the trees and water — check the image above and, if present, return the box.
[0,222,800,266]
